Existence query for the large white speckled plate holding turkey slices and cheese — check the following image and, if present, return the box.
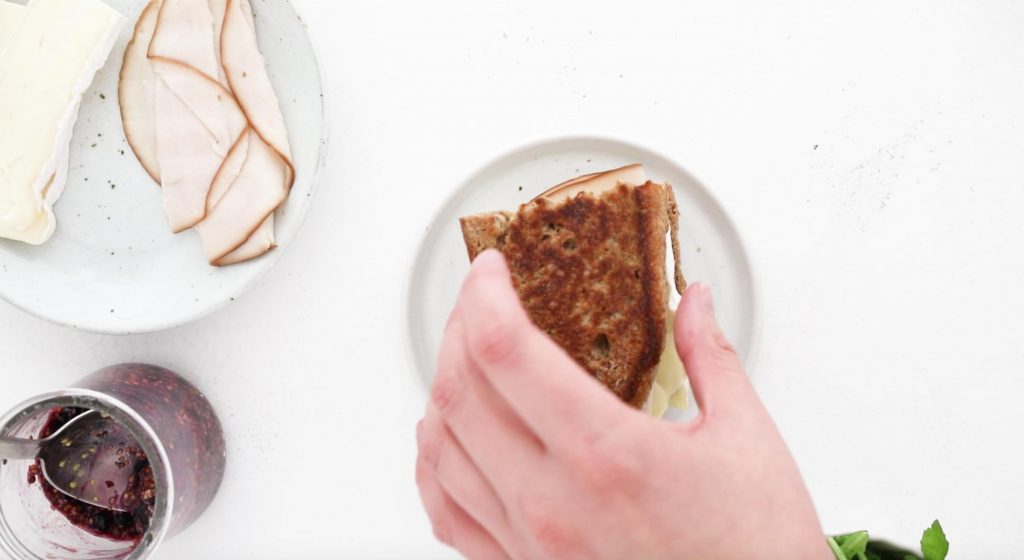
[0,0,328,334]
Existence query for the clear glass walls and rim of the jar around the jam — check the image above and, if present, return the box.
[0,363,224,560]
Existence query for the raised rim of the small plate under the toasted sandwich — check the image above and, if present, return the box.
[401,133,764,394]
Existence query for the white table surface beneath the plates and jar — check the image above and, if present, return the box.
[0,0,1024,560]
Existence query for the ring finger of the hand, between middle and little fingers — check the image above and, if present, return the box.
[418,404,508,540]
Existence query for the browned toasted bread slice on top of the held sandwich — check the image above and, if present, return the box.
[460,181,684,408]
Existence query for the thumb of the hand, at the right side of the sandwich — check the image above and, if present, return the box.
[675,283,753,418]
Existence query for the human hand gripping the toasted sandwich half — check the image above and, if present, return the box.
[416,251,834,560]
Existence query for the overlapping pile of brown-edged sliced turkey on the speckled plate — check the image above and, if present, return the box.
[120,0,295,266]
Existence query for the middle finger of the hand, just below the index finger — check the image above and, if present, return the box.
[428,309,543,499]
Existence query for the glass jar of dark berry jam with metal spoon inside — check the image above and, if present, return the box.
[0,363,225,560]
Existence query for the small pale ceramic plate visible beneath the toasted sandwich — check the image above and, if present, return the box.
[408,137,760,393]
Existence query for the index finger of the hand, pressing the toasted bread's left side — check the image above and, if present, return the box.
[457,251,632,454]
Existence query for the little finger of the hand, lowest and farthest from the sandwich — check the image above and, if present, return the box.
[416,427,509,560]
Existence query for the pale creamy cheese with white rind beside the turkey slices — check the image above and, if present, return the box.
[0,0,125,245]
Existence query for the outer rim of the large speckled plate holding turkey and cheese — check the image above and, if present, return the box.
[0,0,331,335]
